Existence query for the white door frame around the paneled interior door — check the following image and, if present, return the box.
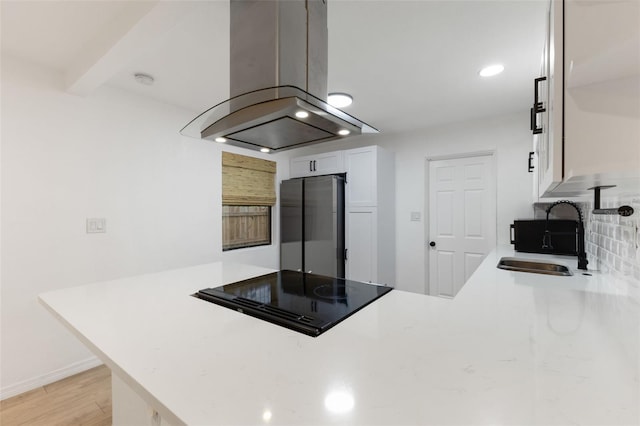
[423,149,498,295]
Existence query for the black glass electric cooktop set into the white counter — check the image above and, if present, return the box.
[194,270,391,337]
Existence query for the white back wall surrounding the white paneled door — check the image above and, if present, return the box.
[287,110,533,293]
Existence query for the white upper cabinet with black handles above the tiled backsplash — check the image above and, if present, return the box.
[532,0,640,198]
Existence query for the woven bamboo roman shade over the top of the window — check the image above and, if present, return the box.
[222,151,276,206]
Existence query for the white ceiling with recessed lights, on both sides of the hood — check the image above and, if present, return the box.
[0,0,547,133]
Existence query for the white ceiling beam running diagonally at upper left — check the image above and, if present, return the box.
[65,0,190,96]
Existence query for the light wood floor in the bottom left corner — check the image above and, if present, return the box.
[0,365,111,426]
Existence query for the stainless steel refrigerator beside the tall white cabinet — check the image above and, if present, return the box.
[280,175,346,278]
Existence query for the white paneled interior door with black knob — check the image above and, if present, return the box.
[427,154,496,297]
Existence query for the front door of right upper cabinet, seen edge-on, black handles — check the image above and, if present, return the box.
[537,0,564,197]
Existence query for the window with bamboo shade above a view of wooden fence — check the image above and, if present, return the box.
[222,152,276,251]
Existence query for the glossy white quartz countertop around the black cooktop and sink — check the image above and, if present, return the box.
[40,248,640,425]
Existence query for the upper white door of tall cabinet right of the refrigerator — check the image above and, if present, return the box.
[345,146,378,206]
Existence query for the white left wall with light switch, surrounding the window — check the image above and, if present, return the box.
[0,56,288,398]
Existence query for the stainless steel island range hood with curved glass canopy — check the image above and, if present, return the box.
[180,0,378,152]
